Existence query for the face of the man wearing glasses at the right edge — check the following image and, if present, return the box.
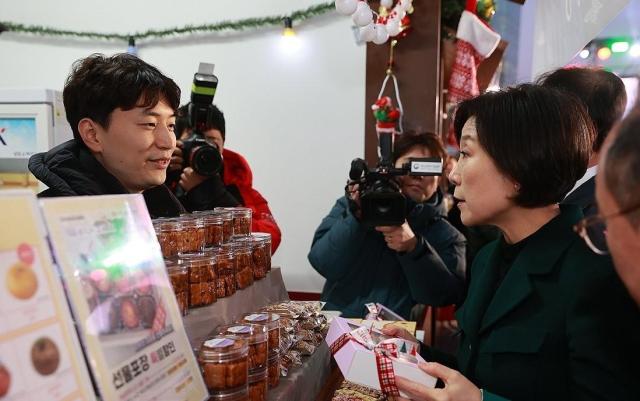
[596,163,640,305]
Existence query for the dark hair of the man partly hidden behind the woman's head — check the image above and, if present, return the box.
[538,67,627,152]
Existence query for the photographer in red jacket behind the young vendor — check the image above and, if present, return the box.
[169,105,282,253]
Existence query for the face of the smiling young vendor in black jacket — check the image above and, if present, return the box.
[94,99,176,193]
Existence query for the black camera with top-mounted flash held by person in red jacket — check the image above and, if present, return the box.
[182,63,222,177]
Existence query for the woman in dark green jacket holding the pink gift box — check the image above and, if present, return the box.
[387,85,640,400]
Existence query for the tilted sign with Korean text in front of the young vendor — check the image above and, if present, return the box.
[41,195,208,401]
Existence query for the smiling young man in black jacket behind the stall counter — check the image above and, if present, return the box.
[29,54,184,217]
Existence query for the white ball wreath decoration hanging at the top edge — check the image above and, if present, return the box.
[335,0,413,45]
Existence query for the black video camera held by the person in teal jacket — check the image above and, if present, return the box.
[347,132,442,227]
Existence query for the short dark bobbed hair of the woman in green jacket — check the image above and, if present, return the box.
[454,84,595,207]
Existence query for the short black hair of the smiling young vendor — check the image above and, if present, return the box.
[63,53,180,143]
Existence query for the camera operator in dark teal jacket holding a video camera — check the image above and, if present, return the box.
[308,134,465,318]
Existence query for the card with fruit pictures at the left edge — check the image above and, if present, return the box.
[0,190,95,401]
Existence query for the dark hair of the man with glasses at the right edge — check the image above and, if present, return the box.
[604,106,640,224]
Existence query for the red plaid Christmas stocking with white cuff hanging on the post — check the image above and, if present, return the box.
[447,0,500,147]
